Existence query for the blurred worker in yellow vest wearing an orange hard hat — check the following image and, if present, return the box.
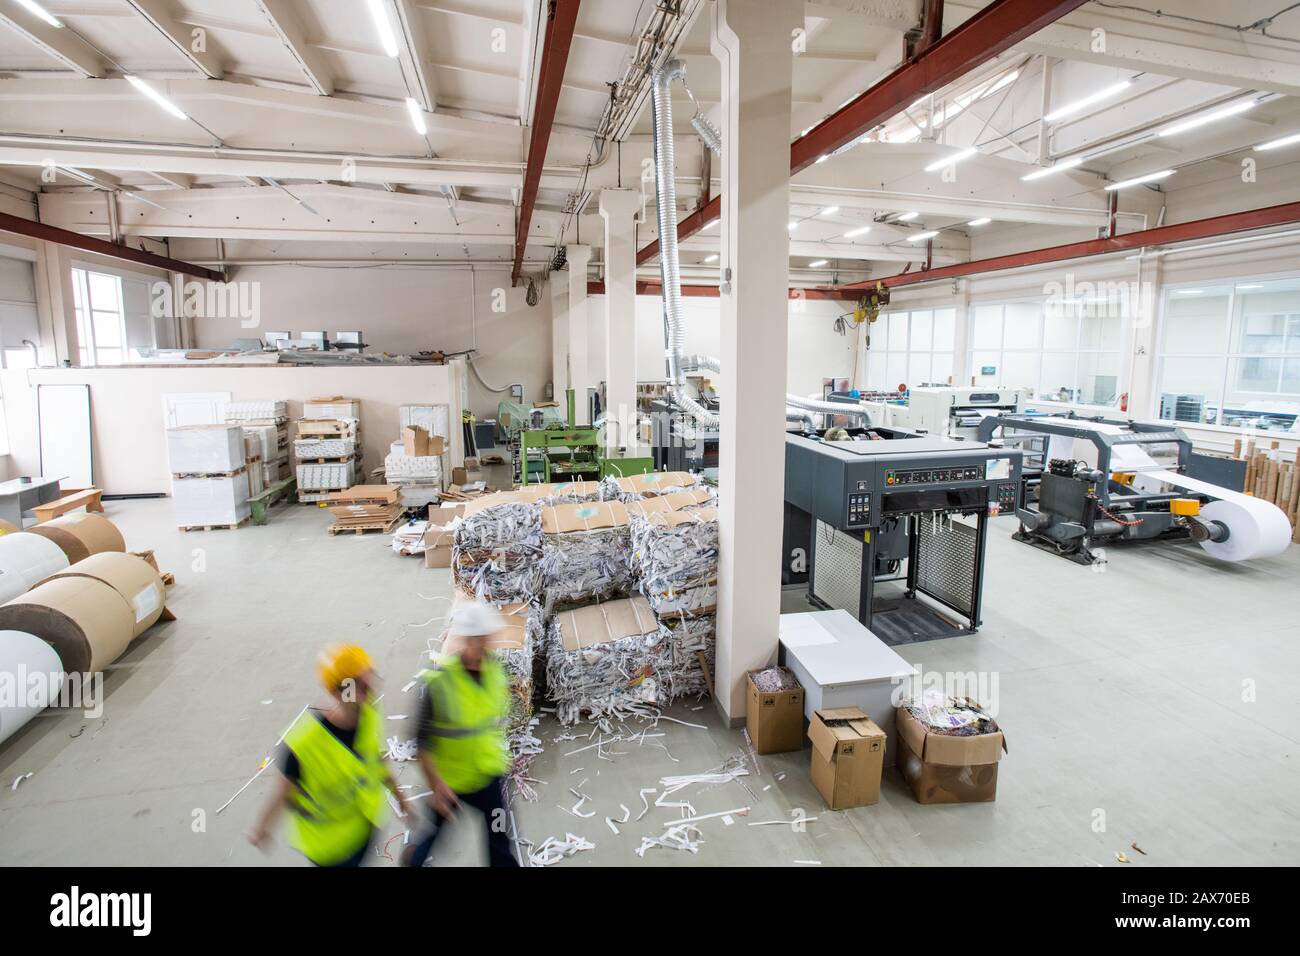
[248,644,407,866]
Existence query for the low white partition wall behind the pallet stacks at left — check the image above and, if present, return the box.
[0,365,463,494]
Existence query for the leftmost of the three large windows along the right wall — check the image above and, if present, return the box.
[866,308,957,390]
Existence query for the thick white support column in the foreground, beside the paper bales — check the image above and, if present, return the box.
[711,0,803,724]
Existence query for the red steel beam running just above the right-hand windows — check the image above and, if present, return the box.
[819,202,1300,299]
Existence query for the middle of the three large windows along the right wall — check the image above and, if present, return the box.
[970,295,1130,405]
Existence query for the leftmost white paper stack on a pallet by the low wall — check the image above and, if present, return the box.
[166,425,250,528]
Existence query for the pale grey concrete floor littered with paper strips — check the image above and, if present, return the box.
[0,499,1300,866]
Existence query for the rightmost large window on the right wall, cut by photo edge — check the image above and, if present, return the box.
[1156,278,1300,431]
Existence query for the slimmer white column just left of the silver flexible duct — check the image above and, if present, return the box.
[601,189,641,455]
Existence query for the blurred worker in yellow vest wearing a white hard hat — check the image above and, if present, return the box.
[402,601,519,866]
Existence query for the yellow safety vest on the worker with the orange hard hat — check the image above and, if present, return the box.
[285,704,386,866]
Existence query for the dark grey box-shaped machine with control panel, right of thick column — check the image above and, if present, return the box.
[785,427,1022,644]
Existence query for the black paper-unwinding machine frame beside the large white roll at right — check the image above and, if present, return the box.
[979,412,1244,564]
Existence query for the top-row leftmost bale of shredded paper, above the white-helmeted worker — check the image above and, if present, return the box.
[451,492,542,604]
